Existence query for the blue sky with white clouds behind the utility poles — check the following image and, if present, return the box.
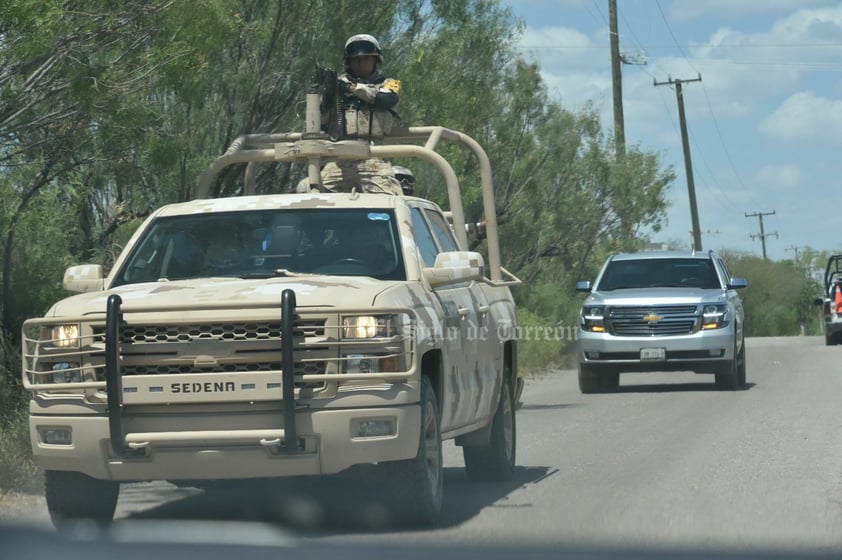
[503,0,842,260]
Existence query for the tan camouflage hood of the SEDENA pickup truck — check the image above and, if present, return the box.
[46,276,398,317]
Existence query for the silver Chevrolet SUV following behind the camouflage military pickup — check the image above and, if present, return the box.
[576,251,748,393]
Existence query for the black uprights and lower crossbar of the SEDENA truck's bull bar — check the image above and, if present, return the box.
[105,289,303,459]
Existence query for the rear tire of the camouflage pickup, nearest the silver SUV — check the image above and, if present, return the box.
[462,378,517,481]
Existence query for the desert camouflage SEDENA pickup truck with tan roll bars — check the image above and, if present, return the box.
[22,95,519,524]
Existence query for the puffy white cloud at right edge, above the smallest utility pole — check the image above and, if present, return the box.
[760,91,842,144]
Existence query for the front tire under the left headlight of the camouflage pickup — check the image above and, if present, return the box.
[44,471,120,527]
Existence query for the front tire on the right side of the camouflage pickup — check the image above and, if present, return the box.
[382,376,444,526]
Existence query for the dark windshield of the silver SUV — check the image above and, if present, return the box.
[597,258,721,291]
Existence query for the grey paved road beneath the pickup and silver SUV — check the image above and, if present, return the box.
[6,337,842,552]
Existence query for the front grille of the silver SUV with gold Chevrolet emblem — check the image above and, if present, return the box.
[607,305,699,336]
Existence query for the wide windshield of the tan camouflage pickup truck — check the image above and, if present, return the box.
[113,209,406,286]
